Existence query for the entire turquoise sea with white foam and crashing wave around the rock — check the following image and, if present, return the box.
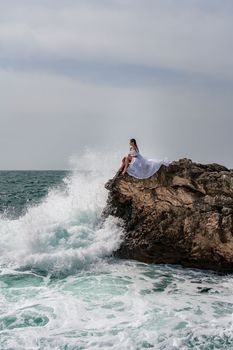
[0,165,233,350]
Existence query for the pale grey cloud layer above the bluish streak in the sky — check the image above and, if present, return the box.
[0,0,233,81]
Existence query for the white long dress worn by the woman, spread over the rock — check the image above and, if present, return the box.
[127,149,171,179]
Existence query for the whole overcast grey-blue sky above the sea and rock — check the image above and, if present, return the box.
[0,0,233,170]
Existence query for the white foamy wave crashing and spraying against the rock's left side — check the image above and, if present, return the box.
[0,151,122,273]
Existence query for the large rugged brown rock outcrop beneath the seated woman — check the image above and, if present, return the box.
[104,158,233,272]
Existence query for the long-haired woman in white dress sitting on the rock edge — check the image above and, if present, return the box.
[119,139,171,179]
